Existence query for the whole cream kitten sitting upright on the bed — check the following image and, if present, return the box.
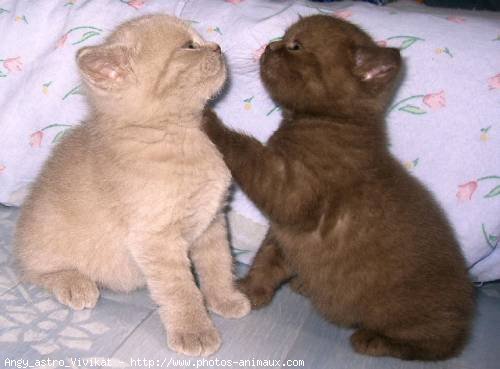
[16,15,250,355]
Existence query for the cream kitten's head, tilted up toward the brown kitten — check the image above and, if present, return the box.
[77,15,226,116]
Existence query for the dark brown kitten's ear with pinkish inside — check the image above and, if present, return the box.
[353,46,401,89]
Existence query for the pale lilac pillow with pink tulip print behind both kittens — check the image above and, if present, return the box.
[0,0,500,281]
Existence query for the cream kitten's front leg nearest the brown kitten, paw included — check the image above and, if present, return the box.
[191,214,250,318]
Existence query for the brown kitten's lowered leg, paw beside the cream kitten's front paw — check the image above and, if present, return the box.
[239,229,293,309]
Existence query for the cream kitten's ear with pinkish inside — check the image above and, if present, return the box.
[76,44,133,90]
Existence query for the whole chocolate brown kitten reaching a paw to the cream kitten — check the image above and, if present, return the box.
[204,16,474,360]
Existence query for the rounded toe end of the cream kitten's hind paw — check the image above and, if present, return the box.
[52,276,99,310]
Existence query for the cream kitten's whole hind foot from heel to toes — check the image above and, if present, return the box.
[28,270,99,310]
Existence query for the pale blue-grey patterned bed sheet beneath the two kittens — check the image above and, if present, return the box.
[0,206,500,369]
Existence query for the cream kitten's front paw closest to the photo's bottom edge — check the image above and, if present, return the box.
[167,327,222,356]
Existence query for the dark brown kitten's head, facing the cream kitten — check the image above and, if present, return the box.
[261,15,401,117]
